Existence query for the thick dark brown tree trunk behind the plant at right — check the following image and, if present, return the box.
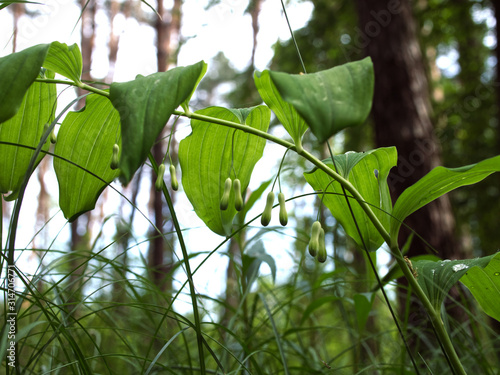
[354,0,464,356]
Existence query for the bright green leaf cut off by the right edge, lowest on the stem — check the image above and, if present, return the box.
[460,253,500,321]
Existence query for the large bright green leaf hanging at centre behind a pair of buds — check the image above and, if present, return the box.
[179,106,271,236]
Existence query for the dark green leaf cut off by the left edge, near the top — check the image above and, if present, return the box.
[0,44,50,123]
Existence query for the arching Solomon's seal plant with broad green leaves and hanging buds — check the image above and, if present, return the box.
[0,42,500,374]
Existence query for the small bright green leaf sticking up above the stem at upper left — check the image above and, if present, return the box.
[43,42,83,83]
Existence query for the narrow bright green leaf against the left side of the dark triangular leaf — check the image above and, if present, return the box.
[254,70,307,151]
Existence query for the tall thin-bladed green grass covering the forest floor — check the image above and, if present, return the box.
[0,204,499,374]
